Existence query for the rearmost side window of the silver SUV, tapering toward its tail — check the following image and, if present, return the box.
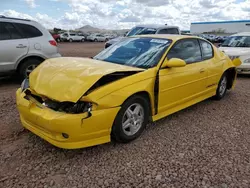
[15,23,43,38]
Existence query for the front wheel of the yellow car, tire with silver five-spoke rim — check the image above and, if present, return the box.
[111,95,150,143]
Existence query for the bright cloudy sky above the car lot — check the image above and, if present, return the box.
[0,0,250,30]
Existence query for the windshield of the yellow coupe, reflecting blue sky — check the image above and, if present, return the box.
[94,38,172,69]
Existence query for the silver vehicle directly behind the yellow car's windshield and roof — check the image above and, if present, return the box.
[105,24,181,48]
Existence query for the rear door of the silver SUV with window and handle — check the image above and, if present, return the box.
[0,22,29,72]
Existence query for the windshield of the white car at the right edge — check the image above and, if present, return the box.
[221,36,250,47]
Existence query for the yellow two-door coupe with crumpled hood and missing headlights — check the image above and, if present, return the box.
[16,35,240,149]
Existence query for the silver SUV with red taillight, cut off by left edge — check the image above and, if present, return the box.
[0,16,61,78]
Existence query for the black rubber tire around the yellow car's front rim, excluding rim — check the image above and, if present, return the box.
[111,95,150,143]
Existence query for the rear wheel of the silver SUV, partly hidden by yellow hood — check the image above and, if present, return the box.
[19,58,43,79]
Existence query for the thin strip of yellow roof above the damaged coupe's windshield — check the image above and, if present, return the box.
[133,34,202,41]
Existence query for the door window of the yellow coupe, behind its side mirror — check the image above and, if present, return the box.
[167,39,202,64]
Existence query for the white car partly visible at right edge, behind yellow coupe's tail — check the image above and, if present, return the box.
[219,32,250,74]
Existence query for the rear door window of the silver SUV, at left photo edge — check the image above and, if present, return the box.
[0,22,22,40]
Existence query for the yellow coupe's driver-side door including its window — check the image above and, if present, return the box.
[158,39,208,113]
